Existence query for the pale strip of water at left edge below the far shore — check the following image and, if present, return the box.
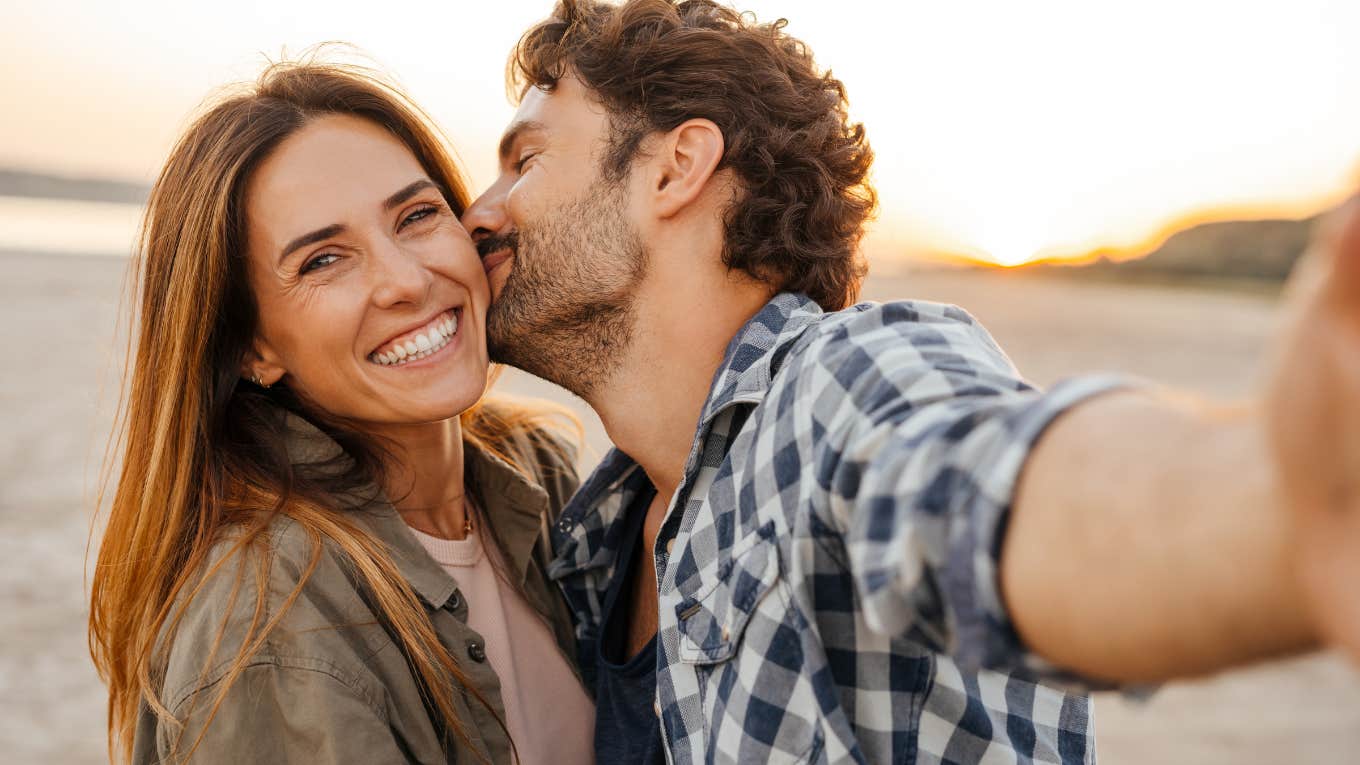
[0,196,141,257]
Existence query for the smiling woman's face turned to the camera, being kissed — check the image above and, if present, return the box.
[243,116,490,426]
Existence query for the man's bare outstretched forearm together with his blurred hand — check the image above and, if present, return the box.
[1001,201,1360,681]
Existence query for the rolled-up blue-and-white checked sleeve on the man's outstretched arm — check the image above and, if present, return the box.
[793,304,1127,679]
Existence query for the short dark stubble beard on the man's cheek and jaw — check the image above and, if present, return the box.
[487,175,647,400]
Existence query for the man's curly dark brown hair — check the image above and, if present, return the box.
[507,0,877,310]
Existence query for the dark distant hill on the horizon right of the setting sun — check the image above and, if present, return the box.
[1038,216,1318,283]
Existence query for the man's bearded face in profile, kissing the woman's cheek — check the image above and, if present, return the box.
[462,76,647,397]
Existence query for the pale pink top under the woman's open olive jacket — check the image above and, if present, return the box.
[411,528,594,765]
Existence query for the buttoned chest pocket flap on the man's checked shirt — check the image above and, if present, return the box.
[676,523,779,666]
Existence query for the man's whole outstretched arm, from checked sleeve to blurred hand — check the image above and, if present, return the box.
[792,200,1360,685]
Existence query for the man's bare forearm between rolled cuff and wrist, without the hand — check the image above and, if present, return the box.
[1001,393,1314,682]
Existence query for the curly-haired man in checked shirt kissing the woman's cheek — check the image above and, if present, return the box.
[464,0,1360,762]
